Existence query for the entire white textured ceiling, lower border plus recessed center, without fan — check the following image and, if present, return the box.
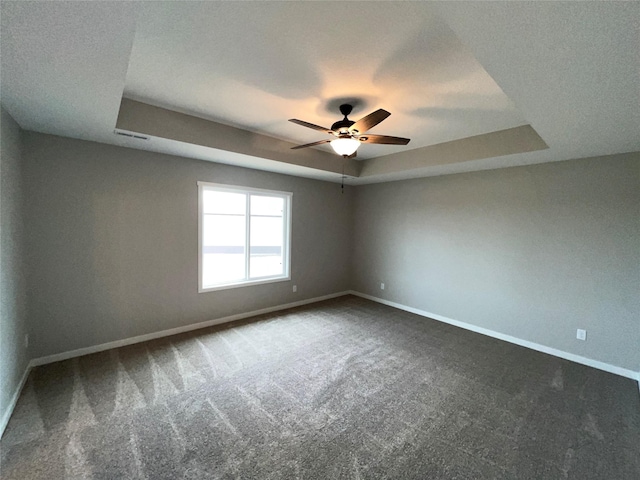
[1,1,640,183]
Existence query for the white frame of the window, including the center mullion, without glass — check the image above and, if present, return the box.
[198,182,293,293]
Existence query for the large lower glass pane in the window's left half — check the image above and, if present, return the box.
[202,215,246,287]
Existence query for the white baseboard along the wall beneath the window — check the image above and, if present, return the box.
[31,292,349,367]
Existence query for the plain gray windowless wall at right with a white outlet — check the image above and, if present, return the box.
[352,153,640,371]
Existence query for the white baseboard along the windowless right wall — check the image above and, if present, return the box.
[348,291,640,382]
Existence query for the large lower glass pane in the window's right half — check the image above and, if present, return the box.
[249,216,284,278]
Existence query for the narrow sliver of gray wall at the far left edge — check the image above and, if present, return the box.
[0,108,29,429]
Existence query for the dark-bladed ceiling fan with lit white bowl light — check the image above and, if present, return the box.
[289,103,409,158]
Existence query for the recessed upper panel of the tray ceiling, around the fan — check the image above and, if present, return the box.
[124,2,528,159]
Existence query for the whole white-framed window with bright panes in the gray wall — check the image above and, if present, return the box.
[198,182,293,292]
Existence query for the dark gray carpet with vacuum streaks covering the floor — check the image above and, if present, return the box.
[0,296,640,480]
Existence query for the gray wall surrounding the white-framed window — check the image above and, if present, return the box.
[24,133,352,357]
